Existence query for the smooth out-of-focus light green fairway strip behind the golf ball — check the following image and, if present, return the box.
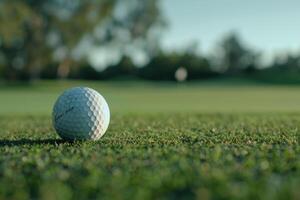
[0,81,300,115]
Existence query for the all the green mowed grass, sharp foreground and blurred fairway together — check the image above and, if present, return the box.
[0,82,300,199]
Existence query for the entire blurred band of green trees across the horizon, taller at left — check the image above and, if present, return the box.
[0,0,300,83]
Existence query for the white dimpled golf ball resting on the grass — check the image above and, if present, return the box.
[52,87,110,140]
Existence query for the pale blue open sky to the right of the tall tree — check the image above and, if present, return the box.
[162,0,300,60]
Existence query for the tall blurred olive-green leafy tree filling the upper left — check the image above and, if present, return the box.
[0,0,162,79]
